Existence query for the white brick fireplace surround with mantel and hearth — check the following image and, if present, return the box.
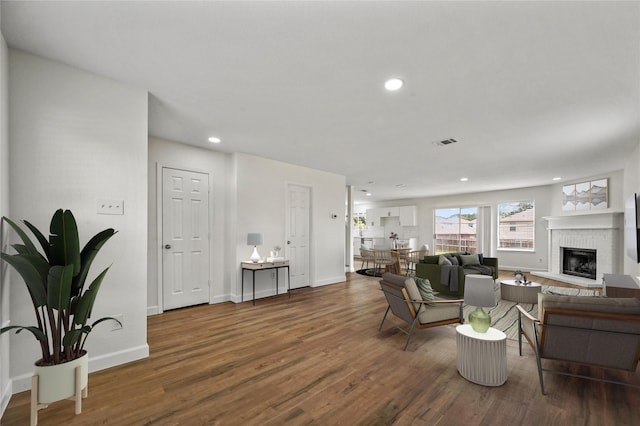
[531,212,624,287]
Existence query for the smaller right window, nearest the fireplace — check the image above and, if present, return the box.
[498,201,536,251]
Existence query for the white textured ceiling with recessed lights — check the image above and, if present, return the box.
[0,1,640,200]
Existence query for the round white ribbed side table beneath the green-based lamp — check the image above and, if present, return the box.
[456,324,507,386]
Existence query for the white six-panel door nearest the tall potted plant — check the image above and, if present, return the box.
[161,167,209,310]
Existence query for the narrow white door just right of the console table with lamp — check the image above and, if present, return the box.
[285,184,311,288]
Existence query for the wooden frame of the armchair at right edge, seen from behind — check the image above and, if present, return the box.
[516,305,640,395]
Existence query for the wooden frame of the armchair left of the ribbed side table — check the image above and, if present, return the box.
[378,281,464,351]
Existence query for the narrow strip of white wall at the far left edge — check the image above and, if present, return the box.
[0,12,12,415]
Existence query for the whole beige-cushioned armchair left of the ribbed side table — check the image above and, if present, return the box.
[378,273,464,351]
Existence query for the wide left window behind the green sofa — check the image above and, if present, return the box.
[434,207,478,254]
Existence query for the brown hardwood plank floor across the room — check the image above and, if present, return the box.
[2,272,640,425]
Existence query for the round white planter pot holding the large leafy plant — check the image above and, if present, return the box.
[33,354,89,404]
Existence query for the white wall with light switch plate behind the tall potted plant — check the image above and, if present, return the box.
[8,49,149,392]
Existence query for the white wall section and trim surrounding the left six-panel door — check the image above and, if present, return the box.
[147,137,231,315]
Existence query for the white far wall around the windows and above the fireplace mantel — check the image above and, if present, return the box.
[364,170,624,271]
